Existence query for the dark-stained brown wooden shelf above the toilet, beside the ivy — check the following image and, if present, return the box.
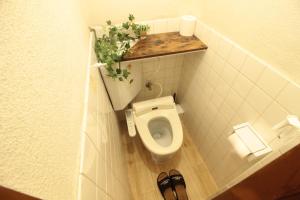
[123,32,207,61]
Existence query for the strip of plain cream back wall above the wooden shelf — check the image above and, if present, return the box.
[87,0,201,25]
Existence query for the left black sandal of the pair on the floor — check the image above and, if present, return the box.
[157,172,176,200]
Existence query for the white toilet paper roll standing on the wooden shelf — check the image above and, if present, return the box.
[179,15,197,36]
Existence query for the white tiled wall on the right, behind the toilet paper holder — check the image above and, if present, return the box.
[178,19,300,188]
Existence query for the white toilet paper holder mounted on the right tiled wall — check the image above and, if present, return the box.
[228,122,272,159]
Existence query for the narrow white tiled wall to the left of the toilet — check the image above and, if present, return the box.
[78,33,132,200]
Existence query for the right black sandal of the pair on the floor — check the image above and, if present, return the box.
[169,169,189,200]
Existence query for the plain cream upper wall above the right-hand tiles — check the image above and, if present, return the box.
[199,0,300,83]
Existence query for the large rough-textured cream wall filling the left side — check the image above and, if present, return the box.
[0,0,88,199]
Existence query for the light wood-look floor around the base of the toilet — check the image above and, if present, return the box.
[122,119,217,200]
